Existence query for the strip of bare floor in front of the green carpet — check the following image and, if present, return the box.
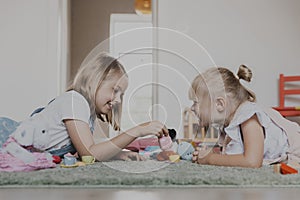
[0,187,300,200]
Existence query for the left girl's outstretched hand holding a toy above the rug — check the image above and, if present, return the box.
[137,121,169,138]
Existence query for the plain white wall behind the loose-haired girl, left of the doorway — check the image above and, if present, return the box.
[0,0,67,121]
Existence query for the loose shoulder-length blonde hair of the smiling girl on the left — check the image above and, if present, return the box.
[68,52,127,130]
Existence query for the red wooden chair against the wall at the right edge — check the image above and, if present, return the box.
[273,74,300,117]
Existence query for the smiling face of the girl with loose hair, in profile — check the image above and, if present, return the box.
[96,74,128,114]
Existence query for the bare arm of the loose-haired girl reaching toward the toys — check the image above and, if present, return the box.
[65,119,168,161]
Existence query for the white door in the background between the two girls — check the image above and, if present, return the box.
[110,14,153,133]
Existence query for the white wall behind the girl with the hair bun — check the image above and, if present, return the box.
[155,0,300,136]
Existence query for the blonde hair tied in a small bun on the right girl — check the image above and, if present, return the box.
[189,65,256,105]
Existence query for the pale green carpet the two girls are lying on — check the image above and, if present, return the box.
[0,160,300,187]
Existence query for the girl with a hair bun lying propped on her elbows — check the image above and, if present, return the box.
[189,65,300,168]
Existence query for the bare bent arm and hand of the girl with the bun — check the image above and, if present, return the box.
[193,115,264,168]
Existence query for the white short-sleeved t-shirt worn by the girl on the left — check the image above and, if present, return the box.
[12,91,93,151]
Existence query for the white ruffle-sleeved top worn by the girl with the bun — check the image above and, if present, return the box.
[224,101,289,160]
